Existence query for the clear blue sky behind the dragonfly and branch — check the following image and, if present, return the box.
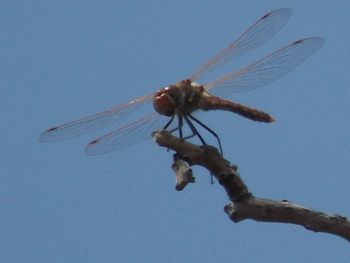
[0,0,350,263]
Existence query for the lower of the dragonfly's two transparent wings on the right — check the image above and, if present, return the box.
[204,37,325,96]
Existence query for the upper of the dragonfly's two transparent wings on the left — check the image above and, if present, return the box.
[39,94,153,142]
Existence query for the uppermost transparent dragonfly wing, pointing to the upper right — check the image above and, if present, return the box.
[190,8,292,81]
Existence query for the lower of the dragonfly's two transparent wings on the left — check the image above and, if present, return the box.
[85,113,169,155]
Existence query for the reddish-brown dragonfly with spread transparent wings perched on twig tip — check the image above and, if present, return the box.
[39,8,325,155]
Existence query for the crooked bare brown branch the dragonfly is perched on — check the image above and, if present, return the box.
[154,131,350,244]
